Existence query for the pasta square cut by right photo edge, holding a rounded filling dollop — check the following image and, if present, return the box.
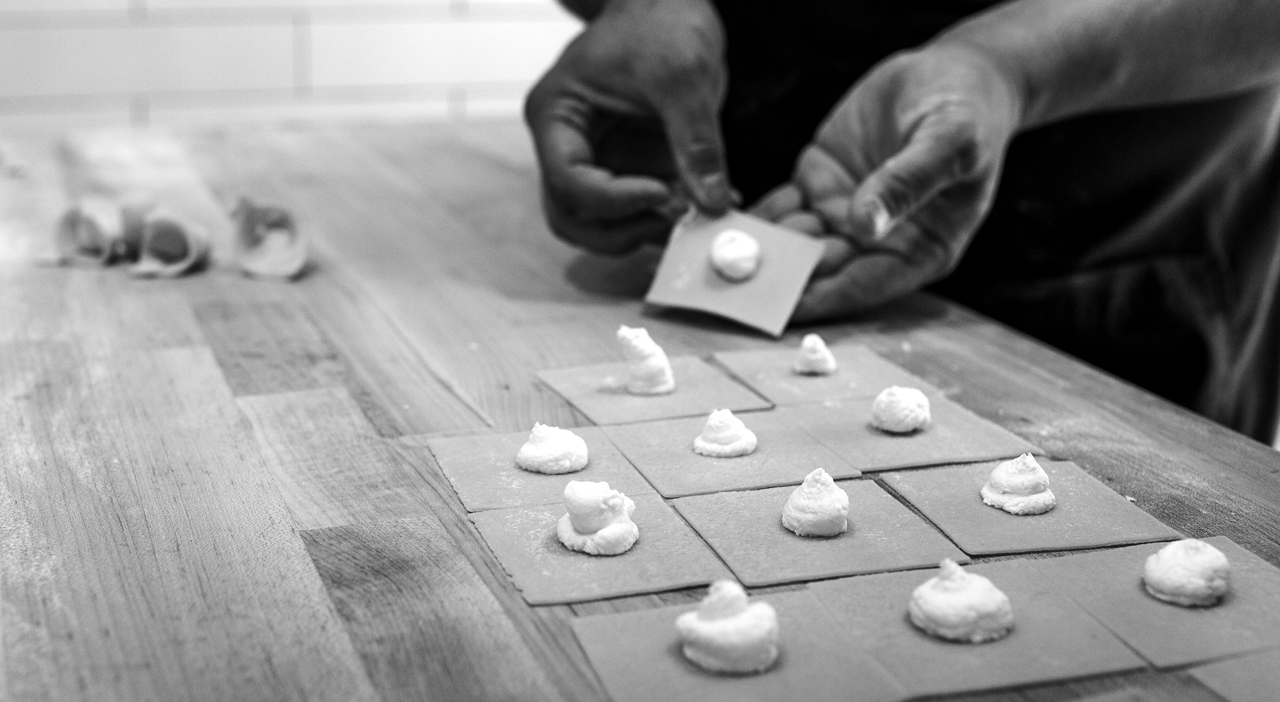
[1034,537,1280,667]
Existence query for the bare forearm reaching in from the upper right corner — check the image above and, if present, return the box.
[933,0,1280,127]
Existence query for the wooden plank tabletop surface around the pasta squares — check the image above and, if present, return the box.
[0,123,1280,702]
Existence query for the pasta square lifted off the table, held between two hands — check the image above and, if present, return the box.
[645,211,823,337]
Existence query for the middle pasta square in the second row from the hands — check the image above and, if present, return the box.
[604,411,861,497]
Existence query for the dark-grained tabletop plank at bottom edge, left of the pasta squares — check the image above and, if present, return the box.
[303,515,561,702]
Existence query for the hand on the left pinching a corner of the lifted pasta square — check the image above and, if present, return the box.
[525,0,733,254]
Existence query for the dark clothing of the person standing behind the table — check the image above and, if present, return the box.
[719,0,1280,442]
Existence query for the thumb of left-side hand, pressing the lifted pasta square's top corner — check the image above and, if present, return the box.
[662,96,735,215]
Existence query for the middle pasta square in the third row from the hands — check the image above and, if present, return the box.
[675,480,968,587]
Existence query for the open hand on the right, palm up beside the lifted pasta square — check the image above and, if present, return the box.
[753,46,1021,323]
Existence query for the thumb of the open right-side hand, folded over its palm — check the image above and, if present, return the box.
[844,112,978,241]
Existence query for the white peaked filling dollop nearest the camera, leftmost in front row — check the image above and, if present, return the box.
[676,580,778,674]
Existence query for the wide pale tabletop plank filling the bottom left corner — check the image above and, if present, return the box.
[0,342,376,702]
